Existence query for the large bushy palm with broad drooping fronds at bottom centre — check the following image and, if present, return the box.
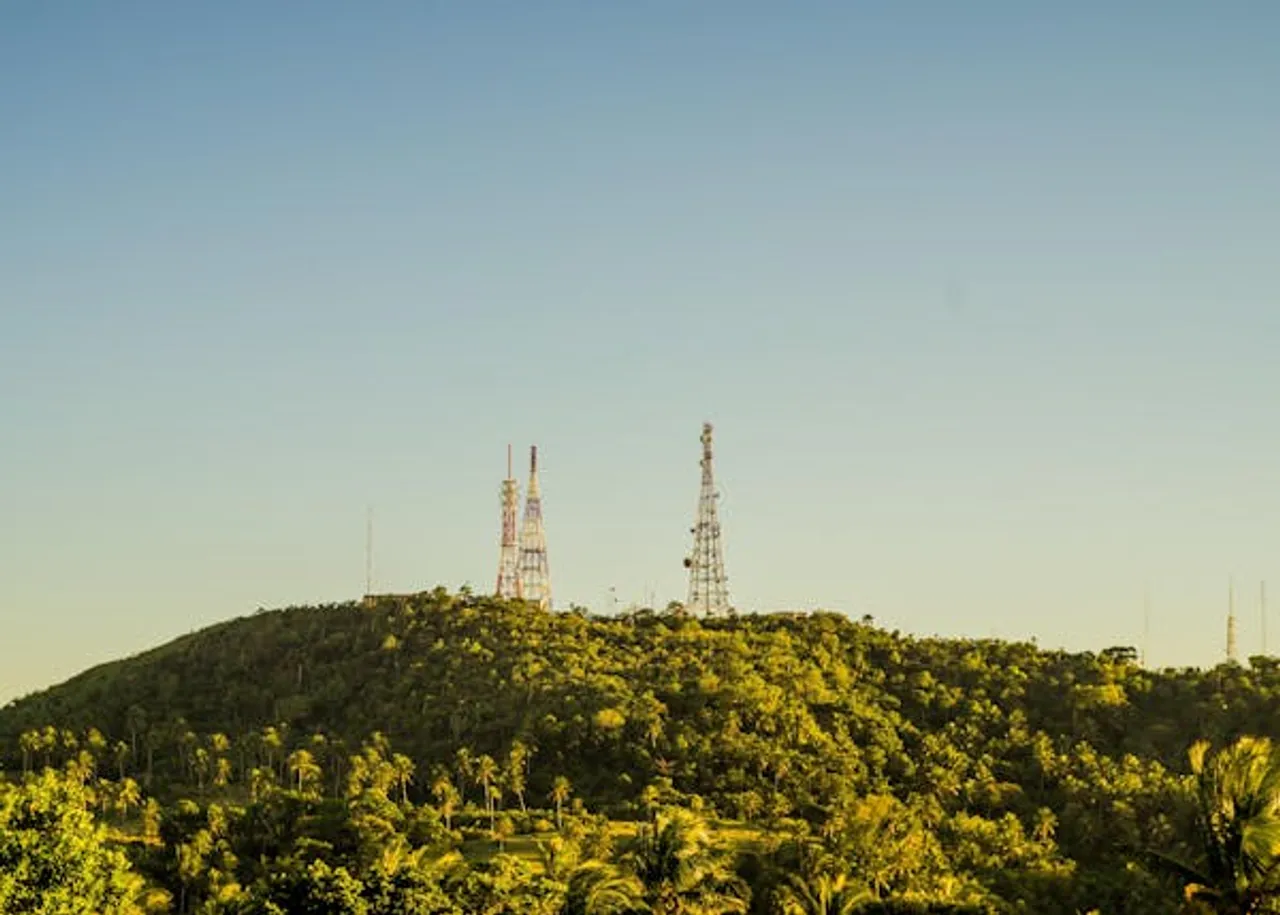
[623,808,750,915]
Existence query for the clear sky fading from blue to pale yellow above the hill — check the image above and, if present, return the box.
[0,0,1280,700]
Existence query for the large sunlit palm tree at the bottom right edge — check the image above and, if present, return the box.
[1155,737,1280,915]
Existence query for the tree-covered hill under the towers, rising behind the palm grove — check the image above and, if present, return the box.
[0,589,1280,799]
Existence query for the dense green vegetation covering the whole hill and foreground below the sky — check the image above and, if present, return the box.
[0,590,1280,915]
